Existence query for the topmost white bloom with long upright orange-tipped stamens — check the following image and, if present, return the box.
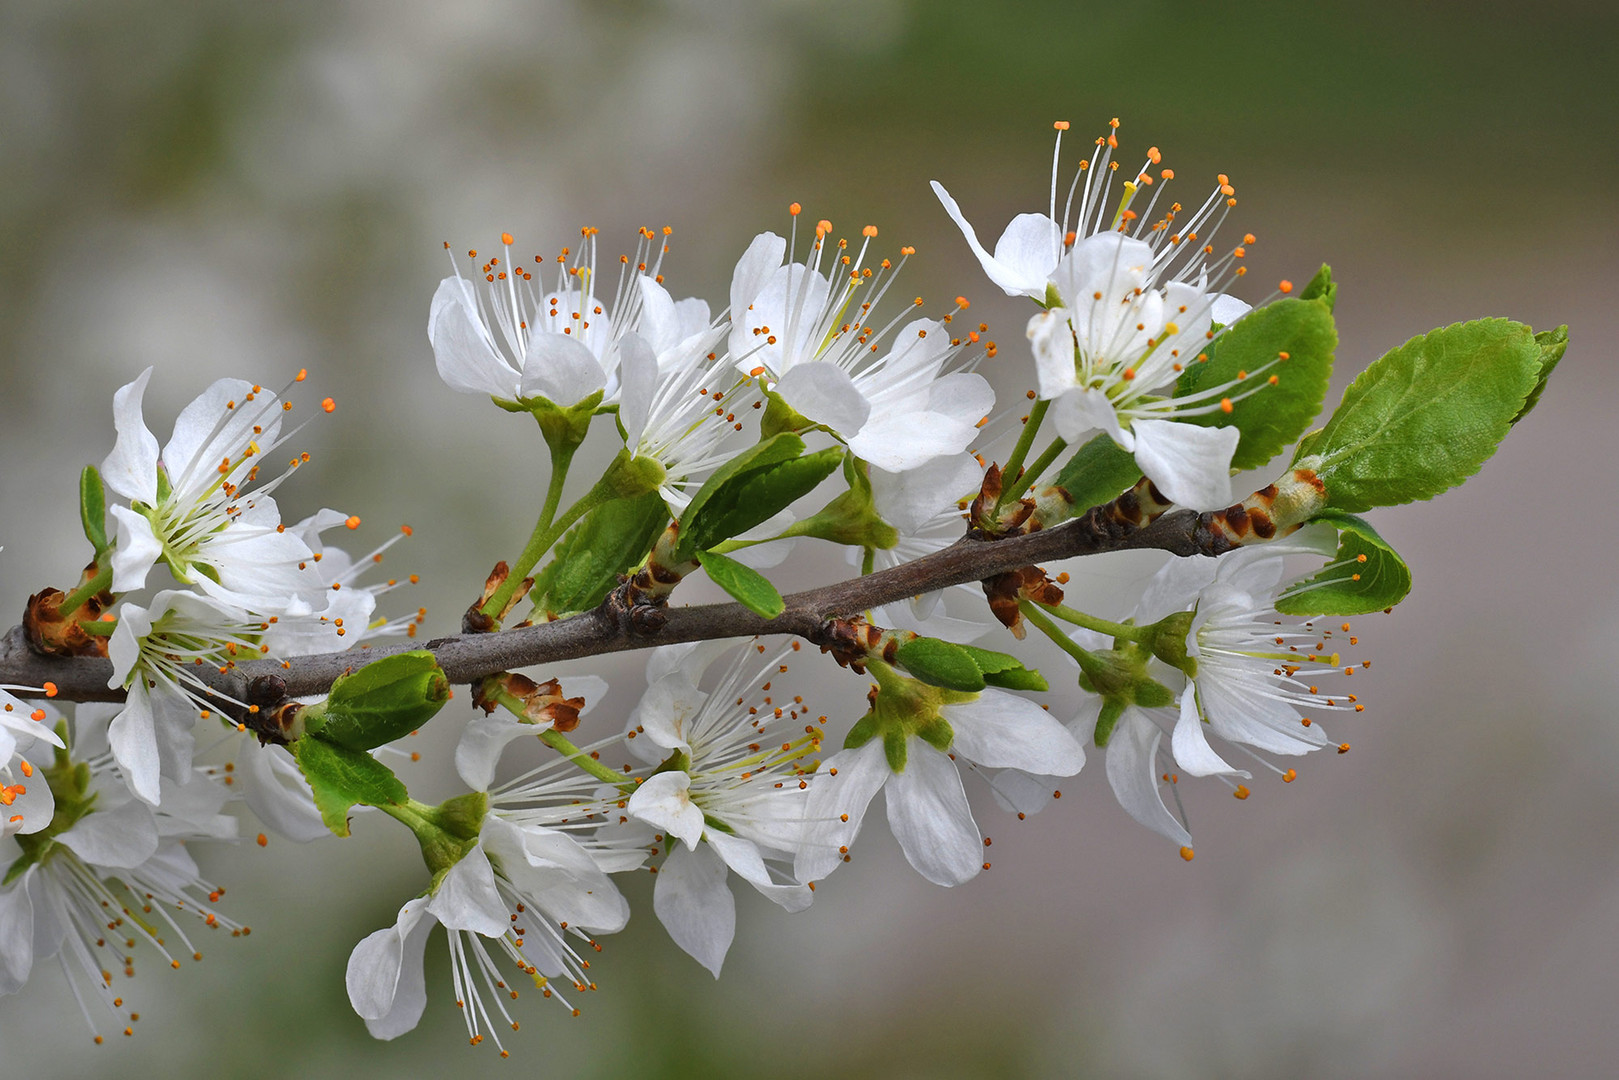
[934,121,1264,510]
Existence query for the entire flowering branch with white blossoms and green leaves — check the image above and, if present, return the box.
[0,121,1566,1056]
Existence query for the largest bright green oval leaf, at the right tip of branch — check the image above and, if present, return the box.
[1295,319,1543,513]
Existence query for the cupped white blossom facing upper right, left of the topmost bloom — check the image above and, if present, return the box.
[730,222,994,473]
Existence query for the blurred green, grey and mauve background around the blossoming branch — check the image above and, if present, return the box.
[0,0,1619,1080]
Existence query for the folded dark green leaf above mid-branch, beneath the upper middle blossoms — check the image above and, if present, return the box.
[675,432,843,562]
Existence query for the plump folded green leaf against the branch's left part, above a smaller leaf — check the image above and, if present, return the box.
[310,649,450,750]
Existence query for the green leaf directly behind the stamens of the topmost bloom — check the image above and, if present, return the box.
[1175,296,1337,470]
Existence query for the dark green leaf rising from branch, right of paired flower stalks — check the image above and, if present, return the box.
[533,491,669,615]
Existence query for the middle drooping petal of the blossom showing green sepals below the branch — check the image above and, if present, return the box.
[887,738,984,886]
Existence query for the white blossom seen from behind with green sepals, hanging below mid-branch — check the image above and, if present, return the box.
[795,664,1085,886]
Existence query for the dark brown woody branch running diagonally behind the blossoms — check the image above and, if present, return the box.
[0,481,1274,701]
